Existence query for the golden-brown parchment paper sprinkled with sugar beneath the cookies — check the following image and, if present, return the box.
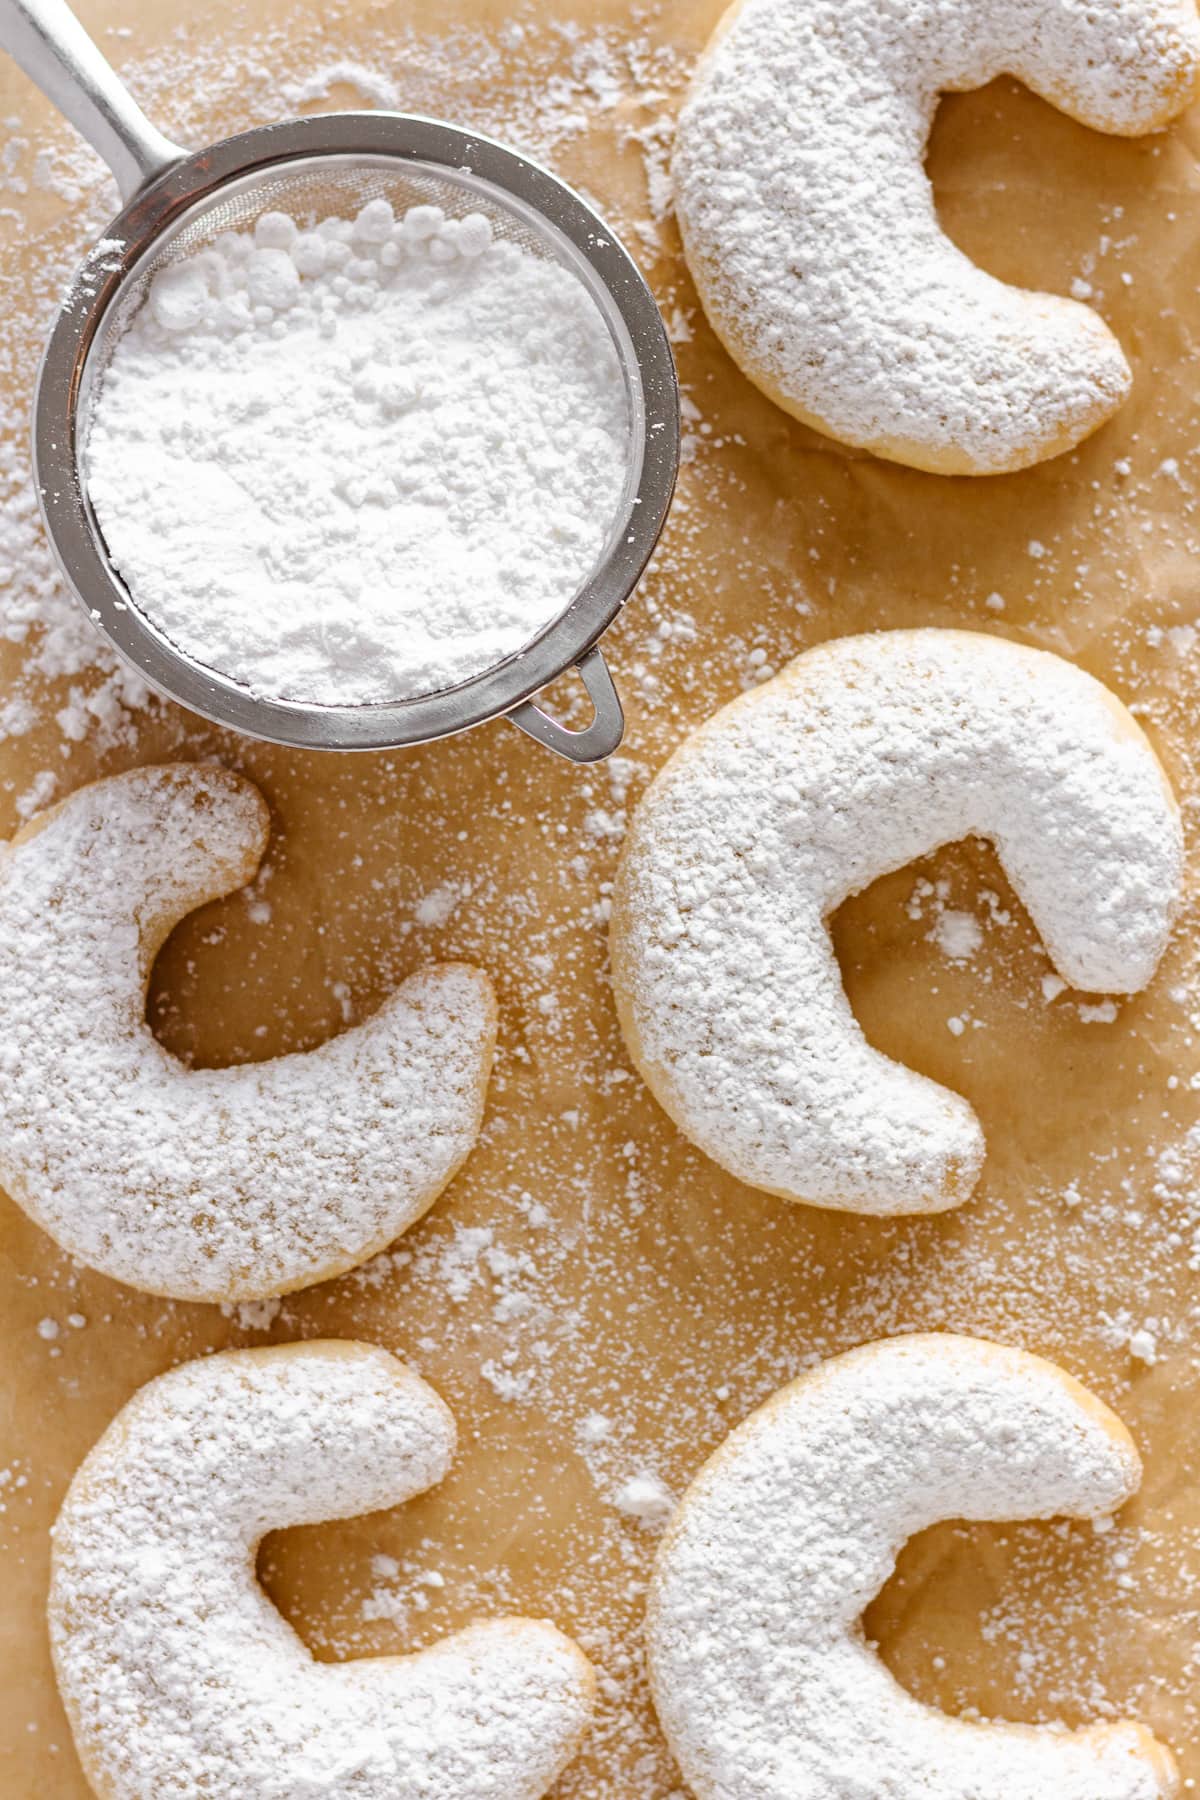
[0,0,1200,1800]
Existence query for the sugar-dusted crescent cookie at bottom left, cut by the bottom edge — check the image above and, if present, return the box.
[50,1341,594,1800]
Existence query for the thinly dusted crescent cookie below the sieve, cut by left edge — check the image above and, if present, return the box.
[0,763,495,1301]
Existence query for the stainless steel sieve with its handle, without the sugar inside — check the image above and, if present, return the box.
[0,0,678,761]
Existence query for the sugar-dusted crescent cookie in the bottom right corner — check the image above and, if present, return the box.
[648,1336,1178,1800]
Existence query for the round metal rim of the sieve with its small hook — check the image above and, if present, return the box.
[32,112,680,761]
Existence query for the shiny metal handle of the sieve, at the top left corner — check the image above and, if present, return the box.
[0,0,184,205]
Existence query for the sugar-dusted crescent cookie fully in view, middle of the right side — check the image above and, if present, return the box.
[612,630,1182,1213]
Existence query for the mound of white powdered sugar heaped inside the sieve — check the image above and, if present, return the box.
[85,200,630,704]
